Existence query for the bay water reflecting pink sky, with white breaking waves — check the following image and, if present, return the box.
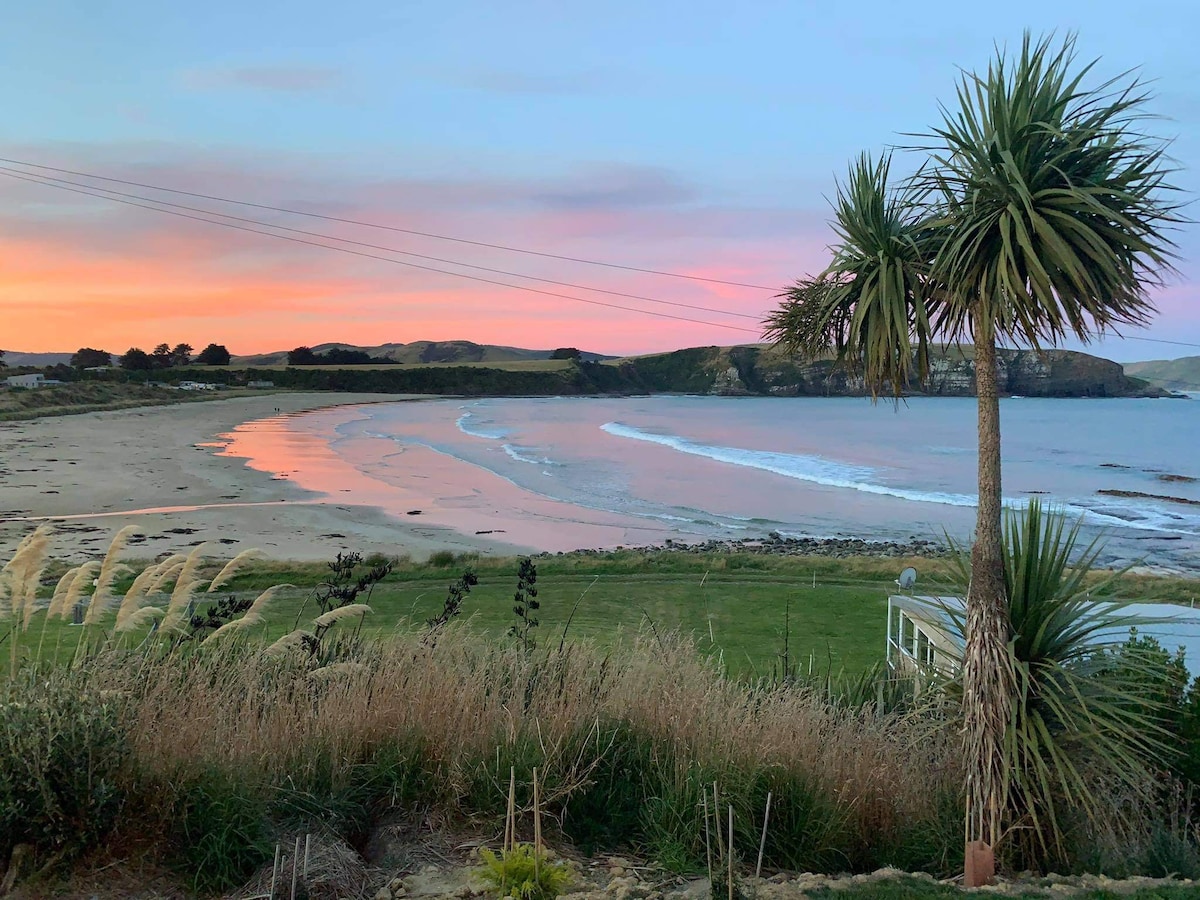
[226,396,1200,569]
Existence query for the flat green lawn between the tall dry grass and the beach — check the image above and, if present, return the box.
[11,551,1196,677]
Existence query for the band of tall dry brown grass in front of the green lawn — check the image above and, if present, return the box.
[91,629,959,868]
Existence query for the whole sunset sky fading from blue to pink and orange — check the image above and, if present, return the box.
[0,0,1200,360]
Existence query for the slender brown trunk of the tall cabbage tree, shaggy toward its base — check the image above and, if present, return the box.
[962,326,1013,887]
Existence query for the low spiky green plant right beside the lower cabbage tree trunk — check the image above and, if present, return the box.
[950,499,1169,868]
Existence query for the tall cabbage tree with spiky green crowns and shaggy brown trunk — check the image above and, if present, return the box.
[764,35,1178,883]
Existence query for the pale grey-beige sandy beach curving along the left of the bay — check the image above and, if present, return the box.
[0,392,535,560]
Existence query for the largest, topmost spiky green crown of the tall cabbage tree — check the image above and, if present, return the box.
[920,35,1180,347]
